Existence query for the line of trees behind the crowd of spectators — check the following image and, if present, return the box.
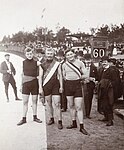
[2,23,124,45]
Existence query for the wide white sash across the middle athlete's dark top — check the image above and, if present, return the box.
[43,62,60,86]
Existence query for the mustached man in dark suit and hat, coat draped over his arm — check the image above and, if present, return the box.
[98,56,118,126]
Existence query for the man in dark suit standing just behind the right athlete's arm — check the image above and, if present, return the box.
[84,54,98,119]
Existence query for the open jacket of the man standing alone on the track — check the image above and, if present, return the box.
[0,61,16,82]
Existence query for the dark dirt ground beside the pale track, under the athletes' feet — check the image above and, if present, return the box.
[47,95,124,150]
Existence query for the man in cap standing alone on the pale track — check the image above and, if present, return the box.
[0,54,20,102]
